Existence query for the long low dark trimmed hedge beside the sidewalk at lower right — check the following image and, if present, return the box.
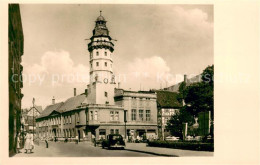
[148,141,214,151]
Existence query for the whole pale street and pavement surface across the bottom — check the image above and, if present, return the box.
[15,142,214,157]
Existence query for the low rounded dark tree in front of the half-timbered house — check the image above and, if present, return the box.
[166,107,194,139]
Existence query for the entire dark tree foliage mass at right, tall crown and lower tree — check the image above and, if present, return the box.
[166,65,214,138]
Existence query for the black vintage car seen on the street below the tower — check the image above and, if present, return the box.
[102,134,125,149]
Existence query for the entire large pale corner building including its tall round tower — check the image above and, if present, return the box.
[36,13,158,141]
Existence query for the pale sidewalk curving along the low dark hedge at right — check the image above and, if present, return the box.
[125,143,214,157]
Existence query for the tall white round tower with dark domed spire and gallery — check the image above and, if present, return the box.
[88,11,116,105]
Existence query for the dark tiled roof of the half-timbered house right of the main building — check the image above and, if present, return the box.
[156,90,182,108]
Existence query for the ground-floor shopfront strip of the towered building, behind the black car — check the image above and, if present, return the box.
[37,124,158,141]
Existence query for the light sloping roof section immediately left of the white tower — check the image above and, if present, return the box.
[59,94,87,112]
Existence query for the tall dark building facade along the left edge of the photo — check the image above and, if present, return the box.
[8,4,24,156]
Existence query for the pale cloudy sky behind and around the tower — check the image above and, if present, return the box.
[20,4,214,108]
